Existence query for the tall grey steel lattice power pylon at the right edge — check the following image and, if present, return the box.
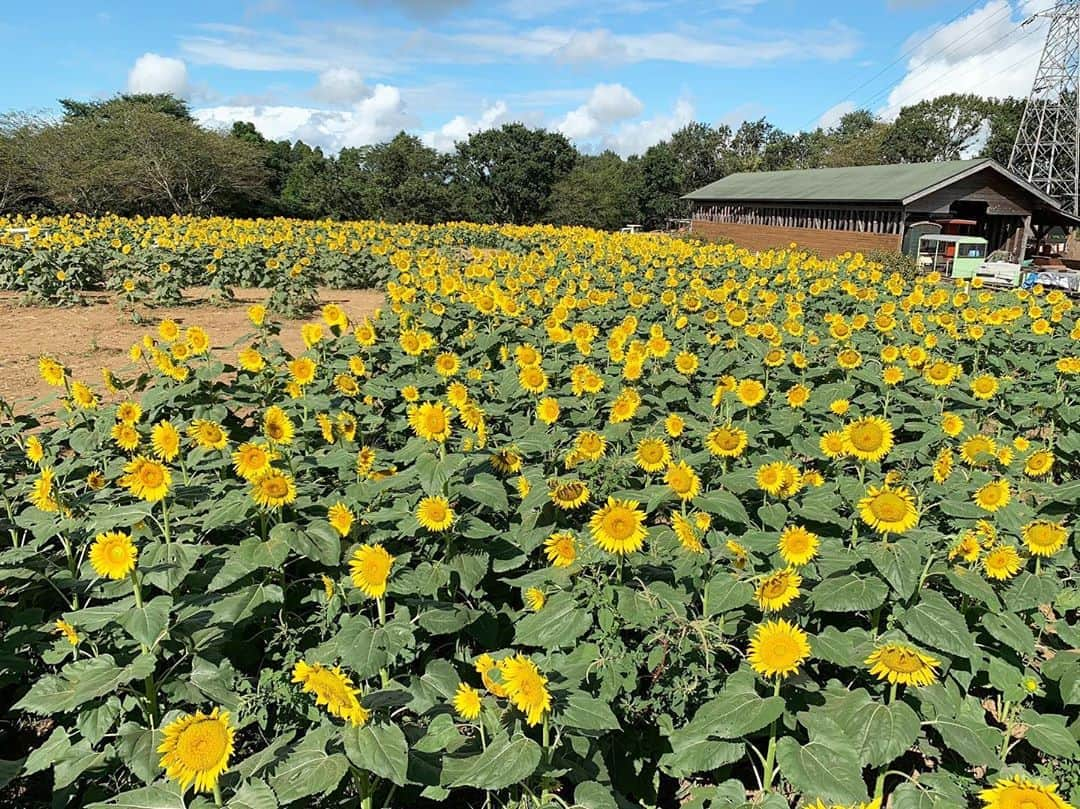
[1009,0,1080,214]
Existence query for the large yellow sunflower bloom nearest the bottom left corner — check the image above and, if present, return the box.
[158,707,234,792]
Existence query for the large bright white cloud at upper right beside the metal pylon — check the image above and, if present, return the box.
[870,0,1052,119]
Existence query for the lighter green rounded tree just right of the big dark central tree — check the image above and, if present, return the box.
[548,151,639,230]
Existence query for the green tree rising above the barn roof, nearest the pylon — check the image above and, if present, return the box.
[881,93,987,163]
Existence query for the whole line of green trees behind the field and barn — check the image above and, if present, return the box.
[0,94,1024,229]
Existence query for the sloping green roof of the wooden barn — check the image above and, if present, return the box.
[683,158,1057,208]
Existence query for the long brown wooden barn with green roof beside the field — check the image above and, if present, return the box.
[684,158,1080,261]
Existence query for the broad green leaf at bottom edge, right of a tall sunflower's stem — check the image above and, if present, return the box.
[777,736,866,804]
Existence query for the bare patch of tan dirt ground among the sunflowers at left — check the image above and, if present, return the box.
[0,288,382,413]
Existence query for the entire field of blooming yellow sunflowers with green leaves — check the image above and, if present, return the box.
[0,220,1080,809]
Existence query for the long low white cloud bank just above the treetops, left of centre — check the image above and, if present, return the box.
[194,84,417,152]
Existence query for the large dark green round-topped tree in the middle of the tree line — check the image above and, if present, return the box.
[453,123,577,225]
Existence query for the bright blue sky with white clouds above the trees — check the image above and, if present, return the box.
[0,0,1052,154]
